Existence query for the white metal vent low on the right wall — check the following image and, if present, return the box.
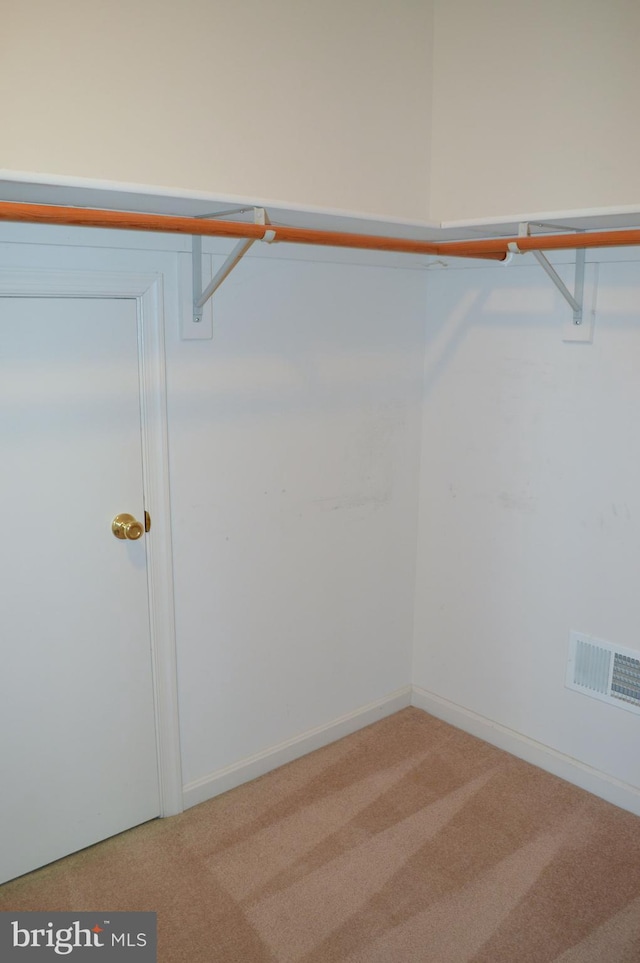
[566,632,640,712]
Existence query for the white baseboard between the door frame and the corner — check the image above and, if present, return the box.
[183,686,411,809]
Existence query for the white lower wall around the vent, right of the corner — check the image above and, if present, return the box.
[413,253,640,811]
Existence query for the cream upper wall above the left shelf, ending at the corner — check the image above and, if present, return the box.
[0,0,432,218]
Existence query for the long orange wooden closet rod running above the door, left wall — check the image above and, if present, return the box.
[0,201,505,261]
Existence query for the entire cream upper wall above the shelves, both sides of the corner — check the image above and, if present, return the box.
[6,0,640,227]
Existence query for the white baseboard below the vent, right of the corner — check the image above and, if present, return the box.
[411,686,640,816]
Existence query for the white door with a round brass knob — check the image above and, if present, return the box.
[0,297,159,882]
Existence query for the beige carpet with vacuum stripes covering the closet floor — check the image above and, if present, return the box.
[0,709,640,963]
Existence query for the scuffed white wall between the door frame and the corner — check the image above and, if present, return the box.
[169,245,425,784]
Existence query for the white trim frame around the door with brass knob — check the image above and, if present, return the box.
[0,268,184,816]
